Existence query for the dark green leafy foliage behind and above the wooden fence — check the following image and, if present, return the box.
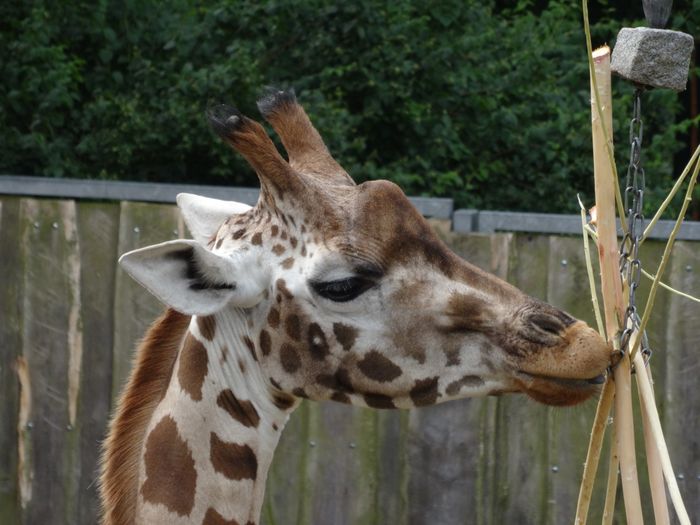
[0,0,688,212]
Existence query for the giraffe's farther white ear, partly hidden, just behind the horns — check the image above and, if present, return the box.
[177,193,250,245]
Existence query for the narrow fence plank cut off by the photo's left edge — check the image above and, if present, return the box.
[0,198,23,523]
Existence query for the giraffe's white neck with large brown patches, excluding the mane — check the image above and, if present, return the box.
[137,310,295,525]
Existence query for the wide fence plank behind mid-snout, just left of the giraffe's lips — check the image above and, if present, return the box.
[407,234,500,525]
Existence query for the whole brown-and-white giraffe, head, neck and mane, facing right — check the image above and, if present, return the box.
[100,90,610,525]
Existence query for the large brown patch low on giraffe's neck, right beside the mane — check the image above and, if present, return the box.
[141,416,197,516]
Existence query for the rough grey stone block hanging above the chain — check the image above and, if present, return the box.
[610,27,694,91]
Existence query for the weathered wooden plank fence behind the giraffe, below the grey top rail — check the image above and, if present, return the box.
[0,197,700,525]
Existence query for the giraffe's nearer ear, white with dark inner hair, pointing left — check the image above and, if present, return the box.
[119,240,270,315]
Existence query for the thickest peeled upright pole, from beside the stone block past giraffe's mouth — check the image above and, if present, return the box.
[591,46,644,525]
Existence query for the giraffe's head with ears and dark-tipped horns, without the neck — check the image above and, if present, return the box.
[122,91,610,408]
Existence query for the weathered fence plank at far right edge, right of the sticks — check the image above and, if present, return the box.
[663,242,700,523]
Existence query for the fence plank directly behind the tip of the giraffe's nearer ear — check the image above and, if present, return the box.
[112,202,182,400]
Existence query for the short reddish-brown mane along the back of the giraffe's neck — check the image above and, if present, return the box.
[100,309,190,525]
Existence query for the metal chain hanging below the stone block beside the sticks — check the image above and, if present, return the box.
[619,87,651,361]
